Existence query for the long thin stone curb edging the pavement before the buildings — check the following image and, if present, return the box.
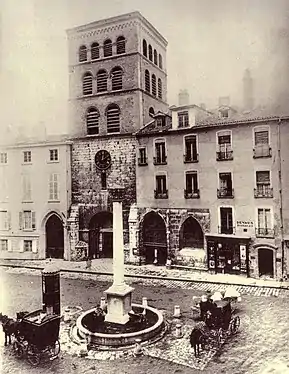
[0,264,289,291]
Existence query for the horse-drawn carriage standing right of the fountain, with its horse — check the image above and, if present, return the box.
[190,299,240,356]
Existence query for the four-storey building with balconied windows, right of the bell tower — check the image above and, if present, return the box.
[135,105,289,278]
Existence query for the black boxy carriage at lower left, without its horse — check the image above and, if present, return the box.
[13,310,60,366]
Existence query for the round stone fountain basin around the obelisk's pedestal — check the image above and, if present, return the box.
[76,304,166,347]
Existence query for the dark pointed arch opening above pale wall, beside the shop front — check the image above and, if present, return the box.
[180,217,204,249]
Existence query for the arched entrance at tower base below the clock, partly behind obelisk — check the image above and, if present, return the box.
[88,212,113,258]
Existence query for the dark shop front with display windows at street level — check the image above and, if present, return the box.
[206,234,251,277]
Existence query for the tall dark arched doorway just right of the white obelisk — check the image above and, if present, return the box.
[142,212,167,265]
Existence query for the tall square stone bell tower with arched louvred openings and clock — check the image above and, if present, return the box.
[67,12,168,259]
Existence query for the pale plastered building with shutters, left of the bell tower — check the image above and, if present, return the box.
[0,139,71,260]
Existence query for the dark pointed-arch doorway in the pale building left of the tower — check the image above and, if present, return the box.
[45,214,64,258]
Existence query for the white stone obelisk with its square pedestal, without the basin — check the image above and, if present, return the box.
[104,199,134,324]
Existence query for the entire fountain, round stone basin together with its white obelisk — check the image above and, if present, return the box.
[76,188,165,349]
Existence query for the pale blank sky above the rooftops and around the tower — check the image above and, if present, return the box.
[0,0,289,133]
